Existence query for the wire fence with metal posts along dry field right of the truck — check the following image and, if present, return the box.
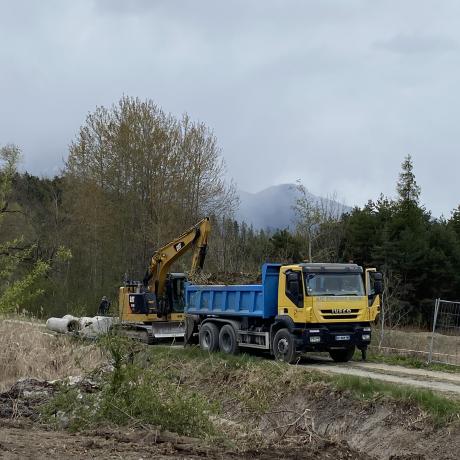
[371,299,460,366]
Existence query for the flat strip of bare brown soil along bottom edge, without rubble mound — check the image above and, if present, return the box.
[0,419,371,460]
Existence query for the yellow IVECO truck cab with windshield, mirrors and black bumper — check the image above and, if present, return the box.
[273,263,382,361]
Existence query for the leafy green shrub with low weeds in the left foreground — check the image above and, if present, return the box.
[41,335,216,437]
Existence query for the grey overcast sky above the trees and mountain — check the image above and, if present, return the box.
[0,0,460,216]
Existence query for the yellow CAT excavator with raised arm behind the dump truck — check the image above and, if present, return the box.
[119,217,211,344]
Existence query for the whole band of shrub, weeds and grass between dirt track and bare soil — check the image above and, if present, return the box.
[42,337,460,438]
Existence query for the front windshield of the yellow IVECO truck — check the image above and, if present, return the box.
[305,273,364,296]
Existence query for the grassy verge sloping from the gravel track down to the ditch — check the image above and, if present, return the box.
[142,347,460,426]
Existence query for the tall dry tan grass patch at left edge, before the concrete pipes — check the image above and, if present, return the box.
[0,319,105,391]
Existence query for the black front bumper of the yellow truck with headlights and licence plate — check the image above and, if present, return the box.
[296,323,371,351]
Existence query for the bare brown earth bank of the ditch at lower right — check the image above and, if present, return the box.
[259,389,460,460]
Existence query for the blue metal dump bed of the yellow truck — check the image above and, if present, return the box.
[185,264,280,318]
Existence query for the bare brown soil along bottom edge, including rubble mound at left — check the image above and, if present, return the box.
[0,378,370,460]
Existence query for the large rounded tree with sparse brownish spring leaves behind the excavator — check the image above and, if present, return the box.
[64,96,236,304]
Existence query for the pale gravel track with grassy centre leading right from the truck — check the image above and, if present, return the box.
[301,357,460,396]
